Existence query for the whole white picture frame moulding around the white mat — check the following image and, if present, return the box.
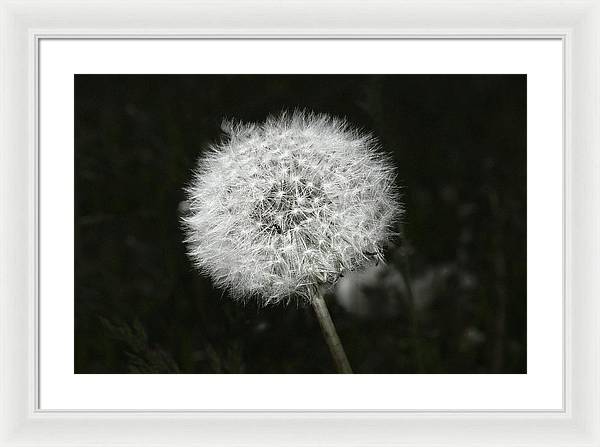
[0,0,600,446]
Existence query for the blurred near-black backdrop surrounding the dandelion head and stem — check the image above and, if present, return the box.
[75,75,526,373]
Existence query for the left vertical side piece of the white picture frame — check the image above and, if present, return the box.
[0,3,30,445]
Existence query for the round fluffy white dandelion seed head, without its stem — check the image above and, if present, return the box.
[183,112,402,305]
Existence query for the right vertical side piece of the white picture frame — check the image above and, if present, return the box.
[569,0,600,446]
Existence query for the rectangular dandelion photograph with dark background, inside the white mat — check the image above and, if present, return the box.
[73,74,527,374]
